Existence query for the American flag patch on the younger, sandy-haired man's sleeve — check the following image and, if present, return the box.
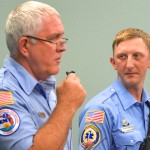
[85,111,105,123]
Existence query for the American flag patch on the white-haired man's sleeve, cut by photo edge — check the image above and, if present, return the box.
[0,91,14,106]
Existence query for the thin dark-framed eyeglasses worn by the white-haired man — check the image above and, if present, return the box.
[24,35,68,48]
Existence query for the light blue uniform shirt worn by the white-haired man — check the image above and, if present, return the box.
[0,57,72,150]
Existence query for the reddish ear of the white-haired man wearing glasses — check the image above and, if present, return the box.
[18,37,31,57]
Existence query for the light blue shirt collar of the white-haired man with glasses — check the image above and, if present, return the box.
[4,57,55,94]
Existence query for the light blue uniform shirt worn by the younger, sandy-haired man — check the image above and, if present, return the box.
[79,79,150,150]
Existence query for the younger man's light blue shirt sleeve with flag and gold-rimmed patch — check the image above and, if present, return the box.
[79,106,112,150]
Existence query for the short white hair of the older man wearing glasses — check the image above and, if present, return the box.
[5,1,60,54]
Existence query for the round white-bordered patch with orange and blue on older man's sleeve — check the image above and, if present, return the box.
[0,109,20,136]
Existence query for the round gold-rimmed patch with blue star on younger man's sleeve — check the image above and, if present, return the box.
[80,124,100,147]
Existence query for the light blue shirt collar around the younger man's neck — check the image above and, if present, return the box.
[113,78,149,110]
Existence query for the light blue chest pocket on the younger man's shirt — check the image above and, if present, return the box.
[113,130,143,150]
